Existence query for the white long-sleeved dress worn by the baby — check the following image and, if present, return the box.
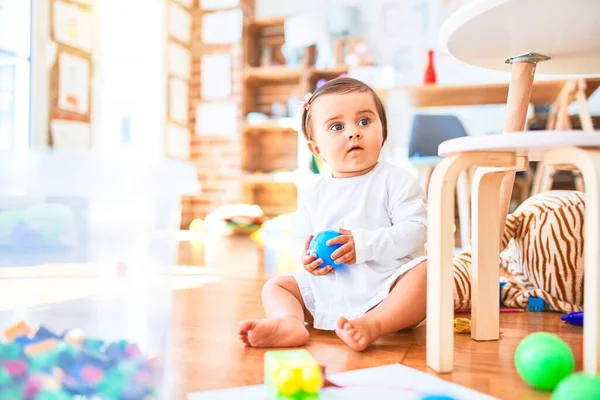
[292,162,427,330]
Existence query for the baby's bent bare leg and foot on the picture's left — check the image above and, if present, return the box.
[238,276,310,347]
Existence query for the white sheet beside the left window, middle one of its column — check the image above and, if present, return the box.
[58,52,90,115]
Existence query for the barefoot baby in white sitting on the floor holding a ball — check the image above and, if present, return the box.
[238,78,427,351]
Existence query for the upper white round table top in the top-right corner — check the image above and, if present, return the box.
[440,0,600,74]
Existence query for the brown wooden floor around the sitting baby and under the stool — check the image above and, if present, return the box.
[175,237,582,400]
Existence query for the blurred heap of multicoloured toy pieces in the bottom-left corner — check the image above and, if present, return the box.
[0,322,156,400]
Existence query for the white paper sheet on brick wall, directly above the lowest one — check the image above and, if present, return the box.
[200,53,231,100]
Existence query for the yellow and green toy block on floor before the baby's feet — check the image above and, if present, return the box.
[265,349,324,400]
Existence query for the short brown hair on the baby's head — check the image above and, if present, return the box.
[302,77,387,143]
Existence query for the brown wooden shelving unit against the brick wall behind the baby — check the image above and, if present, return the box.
[241,18,347,217]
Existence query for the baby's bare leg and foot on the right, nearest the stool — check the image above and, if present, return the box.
[335,261,427,351]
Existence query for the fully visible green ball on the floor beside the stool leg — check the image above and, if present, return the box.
[514,332,575,391]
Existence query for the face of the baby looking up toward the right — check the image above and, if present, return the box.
[309,92,383,178]
